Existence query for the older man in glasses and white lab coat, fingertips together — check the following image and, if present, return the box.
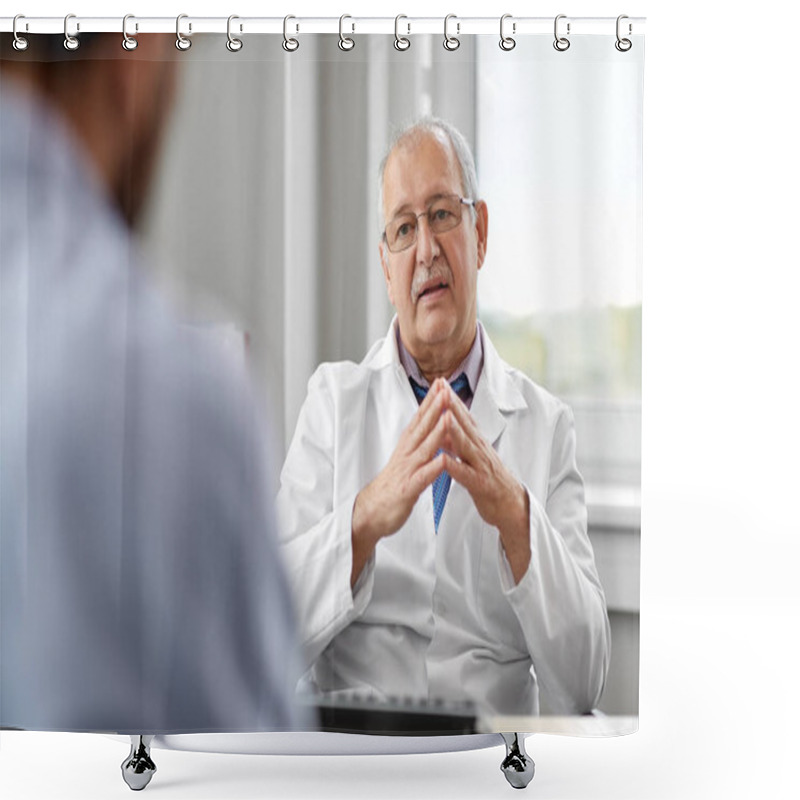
[278,118,609,714]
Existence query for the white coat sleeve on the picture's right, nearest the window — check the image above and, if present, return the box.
[498,407,610,714]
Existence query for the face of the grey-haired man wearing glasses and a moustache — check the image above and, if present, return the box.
[380,133,488,371]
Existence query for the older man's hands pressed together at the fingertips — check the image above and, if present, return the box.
[352,378,530,583]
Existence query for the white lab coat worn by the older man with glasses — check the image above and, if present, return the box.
[278,322,609,714]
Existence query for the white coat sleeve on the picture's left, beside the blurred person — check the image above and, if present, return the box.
[278,368,374,664]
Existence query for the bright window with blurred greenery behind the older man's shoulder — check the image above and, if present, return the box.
[476,42,642,500]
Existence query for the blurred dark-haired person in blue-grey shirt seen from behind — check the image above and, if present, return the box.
[0,34,308,733]
